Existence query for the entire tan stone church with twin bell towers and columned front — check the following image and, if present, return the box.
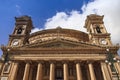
[0,14,120,80]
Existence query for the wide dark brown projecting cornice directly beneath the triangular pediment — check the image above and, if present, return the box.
[2,47,117,55]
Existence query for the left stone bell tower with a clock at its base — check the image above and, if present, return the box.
[8,16,33,47]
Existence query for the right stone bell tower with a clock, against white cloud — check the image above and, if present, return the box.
[85,14,112,45]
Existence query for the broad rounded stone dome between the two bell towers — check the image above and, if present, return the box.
[29,27,89,44]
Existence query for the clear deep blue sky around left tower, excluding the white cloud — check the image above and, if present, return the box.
[0,0,88,54]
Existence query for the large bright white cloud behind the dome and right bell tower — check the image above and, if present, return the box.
[45,0,120,44]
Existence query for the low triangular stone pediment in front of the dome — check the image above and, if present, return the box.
[24,39,99,48]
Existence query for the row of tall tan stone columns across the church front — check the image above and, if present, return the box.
[7,62,120,80]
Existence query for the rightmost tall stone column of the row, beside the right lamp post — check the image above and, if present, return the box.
[101,62,112,80]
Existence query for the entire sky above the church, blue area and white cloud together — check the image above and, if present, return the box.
[0,0,120,54]
